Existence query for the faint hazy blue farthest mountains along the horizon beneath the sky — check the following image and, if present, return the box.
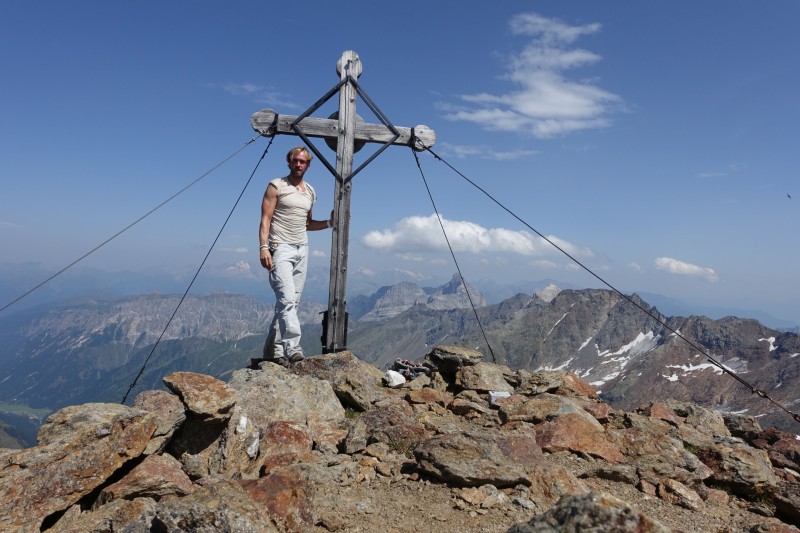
[0,261,800,333]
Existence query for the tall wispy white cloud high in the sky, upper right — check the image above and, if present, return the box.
[442,13,622,139]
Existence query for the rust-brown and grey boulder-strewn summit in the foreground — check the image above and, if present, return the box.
[0,346,800,533]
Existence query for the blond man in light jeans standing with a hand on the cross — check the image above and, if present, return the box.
[253,146,333,366]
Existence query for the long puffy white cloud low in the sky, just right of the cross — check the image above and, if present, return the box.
[361,214,594,257]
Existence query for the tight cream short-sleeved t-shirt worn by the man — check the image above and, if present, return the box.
[269,177,317,245]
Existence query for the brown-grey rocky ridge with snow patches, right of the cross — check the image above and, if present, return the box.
[348,286,800,431]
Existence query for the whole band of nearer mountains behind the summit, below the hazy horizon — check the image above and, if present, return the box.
[0,277,800,444]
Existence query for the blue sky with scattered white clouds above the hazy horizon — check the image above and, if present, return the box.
[0,0,800,323]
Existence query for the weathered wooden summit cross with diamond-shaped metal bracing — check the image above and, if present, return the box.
[250,51,436,353]
